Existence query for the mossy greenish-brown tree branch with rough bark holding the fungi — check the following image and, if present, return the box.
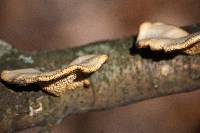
[0,25,200,131]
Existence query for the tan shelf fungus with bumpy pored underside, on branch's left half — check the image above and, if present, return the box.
[1,55,108,96]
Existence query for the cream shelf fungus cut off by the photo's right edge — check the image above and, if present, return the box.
[137,22,200,55]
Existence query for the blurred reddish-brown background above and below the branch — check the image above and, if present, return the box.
[0,0,200,133]
